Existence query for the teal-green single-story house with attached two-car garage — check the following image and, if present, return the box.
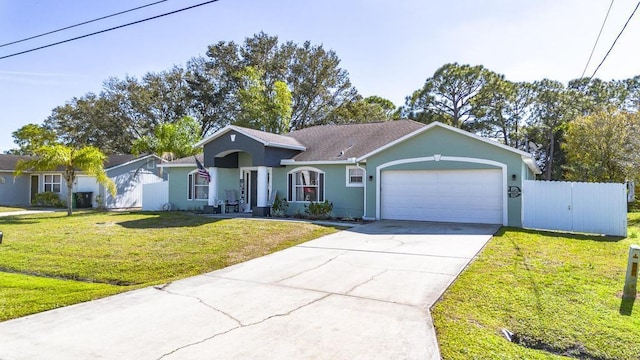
[160,120,540,226]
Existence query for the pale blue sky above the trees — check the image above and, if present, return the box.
[0,0,640,151]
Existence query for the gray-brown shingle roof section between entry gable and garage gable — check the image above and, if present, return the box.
[289,120,425,161]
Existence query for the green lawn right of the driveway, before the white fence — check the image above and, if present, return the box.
[433,213,640,359]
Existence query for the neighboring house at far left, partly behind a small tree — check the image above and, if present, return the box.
[0,154,164,209]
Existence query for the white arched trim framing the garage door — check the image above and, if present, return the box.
[372,156,509,226]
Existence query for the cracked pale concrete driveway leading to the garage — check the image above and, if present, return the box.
[0,221,498,360]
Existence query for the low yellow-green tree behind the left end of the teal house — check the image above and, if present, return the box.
[132,116,200,160]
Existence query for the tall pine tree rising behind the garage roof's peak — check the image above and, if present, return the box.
[403,63,498,131]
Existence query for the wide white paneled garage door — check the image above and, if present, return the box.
[380,169,503,224]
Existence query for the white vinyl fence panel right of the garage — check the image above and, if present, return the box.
[522,180,627,236]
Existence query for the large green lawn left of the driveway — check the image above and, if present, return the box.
[0,212,336,321]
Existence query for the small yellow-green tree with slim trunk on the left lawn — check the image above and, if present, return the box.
[15,144,116,216]
